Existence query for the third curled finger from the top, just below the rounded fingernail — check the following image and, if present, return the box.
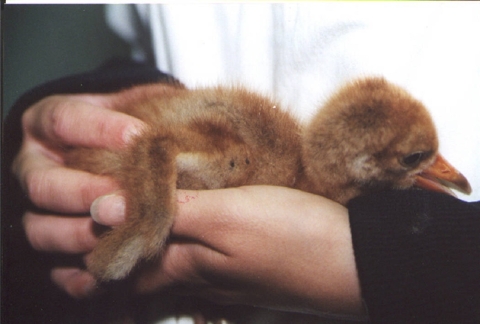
[23,211,99,254]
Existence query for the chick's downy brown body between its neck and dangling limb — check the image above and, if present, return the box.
[114,85,301,189]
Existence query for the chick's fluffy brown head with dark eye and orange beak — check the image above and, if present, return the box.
[298,78,471,204]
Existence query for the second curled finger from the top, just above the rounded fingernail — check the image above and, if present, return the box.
[14,144,118,213]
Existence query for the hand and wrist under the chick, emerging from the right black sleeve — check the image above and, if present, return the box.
[61,186,362,314]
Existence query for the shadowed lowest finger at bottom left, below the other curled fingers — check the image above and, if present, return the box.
[50,268,97,298]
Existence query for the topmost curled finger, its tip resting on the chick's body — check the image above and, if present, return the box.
[22,96,145,149]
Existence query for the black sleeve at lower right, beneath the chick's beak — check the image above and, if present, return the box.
[348,190,480,324]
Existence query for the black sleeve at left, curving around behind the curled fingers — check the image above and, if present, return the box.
[1,60,178,323]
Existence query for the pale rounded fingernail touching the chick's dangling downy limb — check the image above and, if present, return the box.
[90,194,126,226]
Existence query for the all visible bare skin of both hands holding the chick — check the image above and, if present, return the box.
[13,94,362,314]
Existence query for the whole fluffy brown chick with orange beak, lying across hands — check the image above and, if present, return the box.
[65,78,471,281]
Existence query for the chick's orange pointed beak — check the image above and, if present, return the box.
[415,154,472,196]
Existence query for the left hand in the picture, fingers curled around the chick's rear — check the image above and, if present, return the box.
[13,94,144,295]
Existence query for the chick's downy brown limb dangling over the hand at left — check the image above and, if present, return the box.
[68,135,176,281]
